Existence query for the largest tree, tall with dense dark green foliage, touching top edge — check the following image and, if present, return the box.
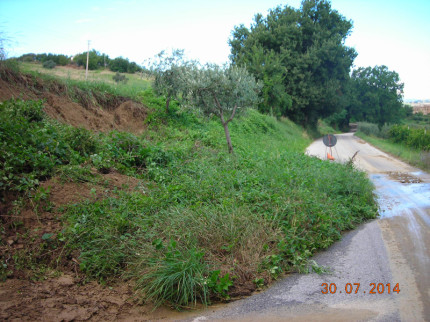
[229,0,356,126]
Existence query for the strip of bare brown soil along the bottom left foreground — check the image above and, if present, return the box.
[0,274,205,321]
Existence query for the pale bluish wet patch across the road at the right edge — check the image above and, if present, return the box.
[370,172,430,218]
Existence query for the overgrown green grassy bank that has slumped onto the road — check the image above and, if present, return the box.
[0,64,377,307]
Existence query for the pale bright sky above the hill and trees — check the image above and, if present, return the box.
[0,0,430,99]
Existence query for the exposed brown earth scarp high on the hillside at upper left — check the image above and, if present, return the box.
[0,70,147,134]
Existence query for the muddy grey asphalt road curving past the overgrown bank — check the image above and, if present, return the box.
[190,133,430,321]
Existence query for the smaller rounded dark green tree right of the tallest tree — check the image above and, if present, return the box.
[347,66,406,127]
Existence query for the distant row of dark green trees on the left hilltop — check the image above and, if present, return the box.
[18,50,142,74]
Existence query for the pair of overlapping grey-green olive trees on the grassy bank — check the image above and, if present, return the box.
[150,50,261,153]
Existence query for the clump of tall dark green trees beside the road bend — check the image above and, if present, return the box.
[229,0,410,130]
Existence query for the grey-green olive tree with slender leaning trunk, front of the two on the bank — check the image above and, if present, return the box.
[181,64,261,153]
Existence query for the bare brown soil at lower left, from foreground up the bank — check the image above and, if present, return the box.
[0,172,160,321]
